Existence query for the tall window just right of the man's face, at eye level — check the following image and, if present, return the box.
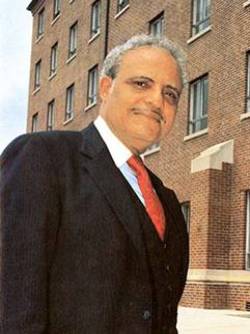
[188,75,208,134]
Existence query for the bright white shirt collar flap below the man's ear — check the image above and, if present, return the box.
[94,115,132,168]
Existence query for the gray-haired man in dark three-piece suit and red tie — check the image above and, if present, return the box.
[0,36,188,334]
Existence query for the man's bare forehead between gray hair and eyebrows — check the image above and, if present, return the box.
[118,46,180,85]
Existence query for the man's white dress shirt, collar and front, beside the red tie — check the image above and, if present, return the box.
[94,115,145,205]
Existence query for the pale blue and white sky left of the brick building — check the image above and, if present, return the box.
[0,0,32,154]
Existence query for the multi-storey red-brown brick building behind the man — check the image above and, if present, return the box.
[27,0,250,310]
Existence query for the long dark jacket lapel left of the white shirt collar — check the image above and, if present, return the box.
[81,124,145,258]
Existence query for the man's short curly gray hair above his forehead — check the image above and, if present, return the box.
[100,34,186,84]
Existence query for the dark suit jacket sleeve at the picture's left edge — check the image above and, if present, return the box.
[0,134,59,334]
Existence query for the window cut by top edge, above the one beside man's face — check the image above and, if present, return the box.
[192,0,210,36]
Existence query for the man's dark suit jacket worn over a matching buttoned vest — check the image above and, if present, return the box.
[0,125,188,334]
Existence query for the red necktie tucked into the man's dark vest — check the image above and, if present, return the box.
[128,155,165,240]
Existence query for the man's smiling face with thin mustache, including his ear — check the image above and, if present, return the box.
[100,46,182,153]
